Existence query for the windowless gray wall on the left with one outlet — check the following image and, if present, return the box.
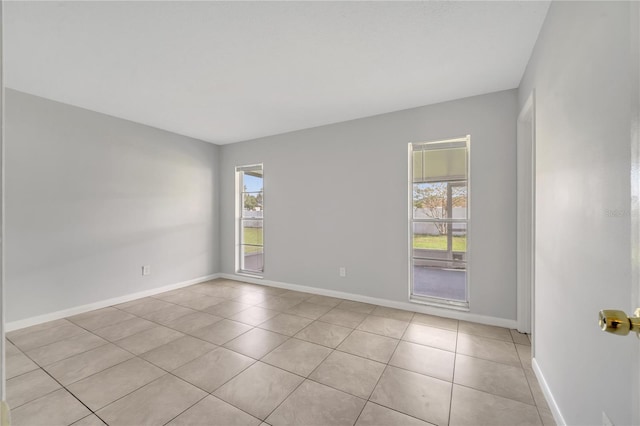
[5,90,219,322]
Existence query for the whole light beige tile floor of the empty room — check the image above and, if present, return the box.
[7,280,554,426]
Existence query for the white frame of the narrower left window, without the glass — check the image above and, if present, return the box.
[235,163,265,278]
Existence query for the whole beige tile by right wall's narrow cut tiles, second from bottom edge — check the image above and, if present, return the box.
[454,354,535,405]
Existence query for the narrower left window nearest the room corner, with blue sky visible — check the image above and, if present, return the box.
[236,164,264,275]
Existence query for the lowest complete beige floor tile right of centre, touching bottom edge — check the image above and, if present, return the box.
[370,367,452,425]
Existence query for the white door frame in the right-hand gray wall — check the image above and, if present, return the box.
[516,90,536,338]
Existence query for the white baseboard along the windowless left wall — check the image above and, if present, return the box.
[5,274,220,332]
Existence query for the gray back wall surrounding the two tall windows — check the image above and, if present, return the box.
[220,90,517,320]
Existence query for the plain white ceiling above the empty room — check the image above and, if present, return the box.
[4,1,549,144]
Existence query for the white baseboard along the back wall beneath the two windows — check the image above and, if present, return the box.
[219,273,517,328]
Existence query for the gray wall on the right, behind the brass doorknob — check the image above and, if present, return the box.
[519,2,640,425]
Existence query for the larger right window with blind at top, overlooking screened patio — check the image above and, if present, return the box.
[409,136,469,308]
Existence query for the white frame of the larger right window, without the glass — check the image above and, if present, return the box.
[407,135,471,311]
